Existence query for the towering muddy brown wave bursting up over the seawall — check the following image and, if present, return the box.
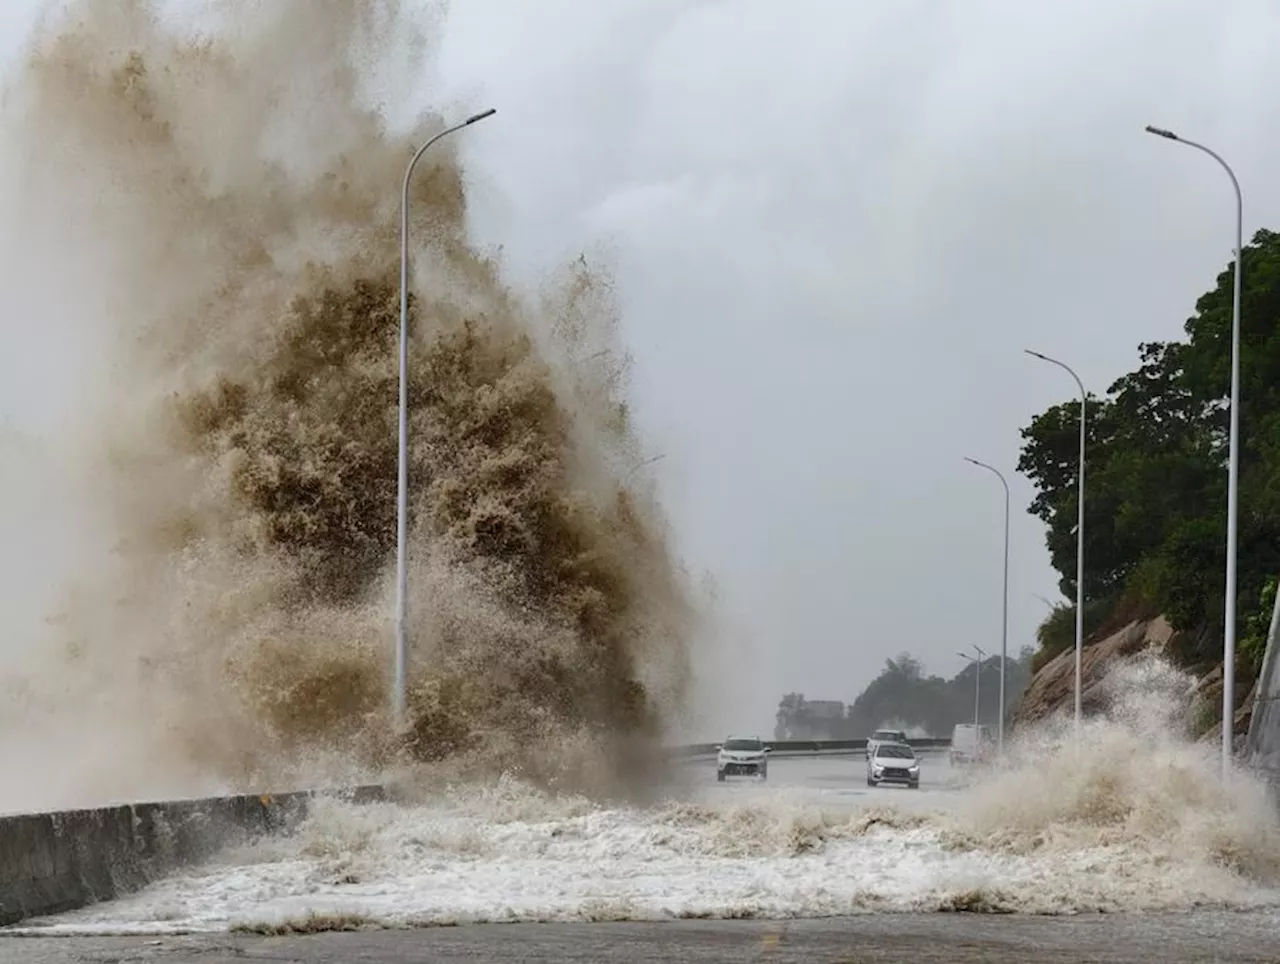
[0,0,698,809]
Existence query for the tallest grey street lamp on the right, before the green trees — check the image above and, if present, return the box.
[1147,124,1244,780]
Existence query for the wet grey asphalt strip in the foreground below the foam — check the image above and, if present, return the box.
[0,913,1280,964]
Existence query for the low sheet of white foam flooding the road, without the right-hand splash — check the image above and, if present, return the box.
[12,764,1280,933]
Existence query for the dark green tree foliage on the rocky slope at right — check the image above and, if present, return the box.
[1018,230,1280,663]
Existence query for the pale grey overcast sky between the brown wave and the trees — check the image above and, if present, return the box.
[0,0,1280,735]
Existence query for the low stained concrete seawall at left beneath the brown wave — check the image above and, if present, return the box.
[0,786,384,927]
